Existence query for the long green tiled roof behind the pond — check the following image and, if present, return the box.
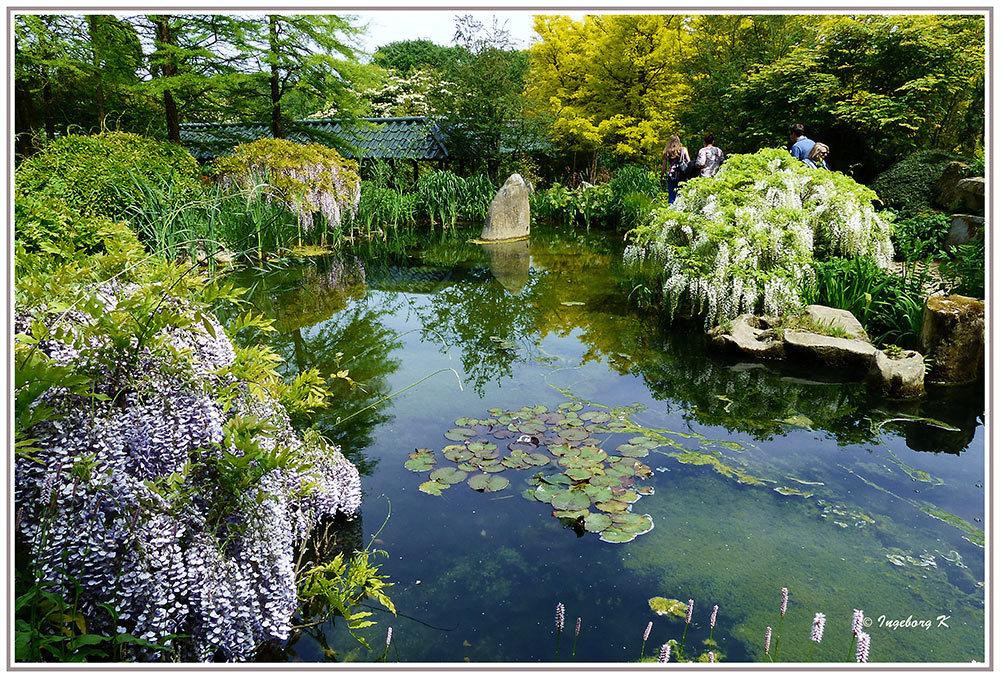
[181,117,448,160]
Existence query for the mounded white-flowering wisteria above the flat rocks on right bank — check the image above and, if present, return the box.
[625,149,893,325]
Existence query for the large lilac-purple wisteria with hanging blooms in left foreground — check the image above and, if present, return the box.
[14,285,361,661]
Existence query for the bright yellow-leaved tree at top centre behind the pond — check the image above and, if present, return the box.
[526,14,691,174]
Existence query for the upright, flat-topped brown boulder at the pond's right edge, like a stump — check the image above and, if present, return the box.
[920,294,986,384]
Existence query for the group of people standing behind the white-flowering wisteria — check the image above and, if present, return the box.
[660,123,830,205]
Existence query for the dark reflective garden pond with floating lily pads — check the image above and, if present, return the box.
[232,226,985,663]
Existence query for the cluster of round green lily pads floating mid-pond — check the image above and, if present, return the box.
[404,401,661,543]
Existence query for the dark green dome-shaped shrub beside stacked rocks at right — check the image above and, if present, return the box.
[872,149,968,216]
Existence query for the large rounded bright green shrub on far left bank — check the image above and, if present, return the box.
[14,132,199,219]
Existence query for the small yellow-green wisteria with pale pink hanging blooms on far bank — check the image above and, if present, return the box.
[214,139,361,231]
